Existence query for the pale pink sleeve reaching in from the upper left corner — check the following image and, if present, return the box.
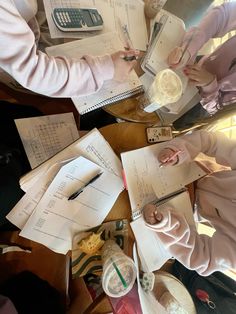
[0,0,114,97]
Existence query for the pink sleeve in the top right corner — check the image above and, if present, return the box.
[183,2,236,58]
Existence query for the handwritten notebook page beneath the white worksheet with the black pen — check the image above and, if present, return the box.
[20,129,122,192]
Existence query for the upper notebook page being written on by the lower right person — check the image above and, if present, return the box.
[121,143,205,213]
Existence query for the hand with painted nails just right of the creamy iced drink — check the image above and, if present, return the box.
[184,64,215,87]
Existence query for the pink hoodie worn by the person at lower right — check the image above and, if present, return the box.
[147,131,236,276]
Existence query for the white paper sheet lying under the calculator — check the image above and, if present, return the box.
[43,0,148,51]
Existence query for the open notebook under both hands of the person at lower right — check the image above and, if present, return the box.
[121,143,205,271]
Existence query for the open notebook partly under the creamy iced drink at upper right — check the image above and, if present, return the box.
[141,10,200,116]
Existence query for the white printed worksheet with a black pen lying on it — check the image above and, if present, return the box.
[20,157,123,254]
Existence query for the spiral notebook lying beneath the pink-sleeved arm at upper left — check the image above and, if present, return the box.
[46,32,143,115]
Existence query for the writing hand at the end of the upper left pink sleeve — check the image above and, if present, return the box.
[111,50,139,82]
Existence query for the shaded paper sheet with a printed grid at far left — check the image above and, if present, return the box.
[15,112,79,169]
